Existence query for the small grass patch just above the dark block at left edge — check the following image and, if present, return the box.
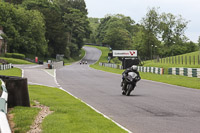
[0,68,22,77]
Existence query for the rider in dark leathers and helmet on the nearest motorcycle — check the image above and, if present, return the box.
[121,65,141,90]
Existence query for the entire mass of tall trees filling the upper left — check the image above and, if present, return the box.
[0,0,91,58]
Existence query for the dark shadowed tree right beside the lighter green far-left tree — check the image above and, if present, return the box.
[23,0,67,57]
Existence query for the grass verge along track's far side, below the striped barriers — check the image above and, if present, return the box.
[90,46,200,89]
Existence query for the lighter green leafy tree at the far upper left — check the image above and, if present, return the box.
[0,2,47,55]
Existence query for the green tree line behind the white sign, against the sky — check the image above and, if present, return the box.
[87,7,198,59]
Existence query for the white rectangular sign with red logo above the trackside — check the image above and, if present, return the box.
[113,50,137,57]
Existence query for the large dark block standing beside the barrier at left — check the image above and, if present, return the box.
[0,75,30,108]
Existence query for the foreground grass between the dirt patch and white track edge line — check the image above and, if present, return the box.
[29,85,126,133]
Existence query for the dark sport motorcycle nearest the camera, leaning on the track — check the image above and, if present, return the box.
[122,72,140,96]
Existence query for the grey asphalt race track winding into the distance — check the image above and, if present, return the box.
[17,47,200,133]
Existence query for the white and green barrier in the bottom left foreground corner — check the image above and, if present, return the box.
[0,79,11,133]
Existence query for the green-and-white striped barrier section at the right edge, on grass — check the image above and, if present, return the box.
[168,67,200,78]
